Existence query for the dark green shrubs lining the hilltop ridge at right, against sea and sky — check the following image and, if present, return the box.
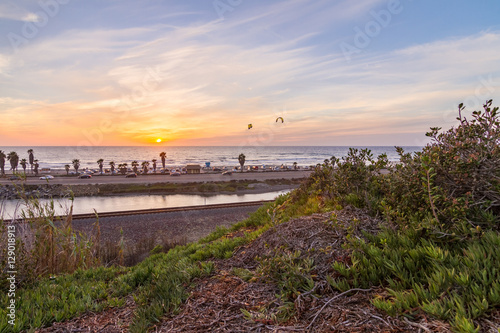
[295,100,500,240]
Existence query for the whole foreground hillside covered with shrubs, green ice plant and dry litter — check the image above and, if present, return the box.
[0,101,500,332]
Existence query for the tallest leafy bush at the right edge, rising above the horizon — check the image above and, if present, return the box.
[383,100,500,236]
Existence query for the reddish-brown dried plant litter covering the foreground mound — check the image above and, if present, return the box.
[155,208,442,332]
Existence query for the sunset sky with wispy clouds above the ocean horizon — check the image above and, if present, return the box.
[0,0,500,146]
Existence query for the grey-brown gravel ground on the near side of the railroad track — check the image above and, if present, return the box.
[73,205,260,243]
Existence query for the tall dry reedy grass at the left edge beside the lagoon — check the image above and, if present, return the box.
[0,188,100,289]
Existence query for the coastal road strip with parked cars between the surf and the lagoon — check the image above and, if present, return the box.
[0,170,311,185]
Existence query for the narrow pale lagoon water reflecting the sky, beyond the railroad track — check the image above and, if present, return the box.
[0,190,289,219]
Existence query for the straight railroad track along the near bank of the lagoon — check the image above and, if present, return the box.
[8,200,274,223]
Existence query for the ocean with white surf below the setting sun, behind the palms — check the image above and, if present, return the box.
[0,145,422,170]
